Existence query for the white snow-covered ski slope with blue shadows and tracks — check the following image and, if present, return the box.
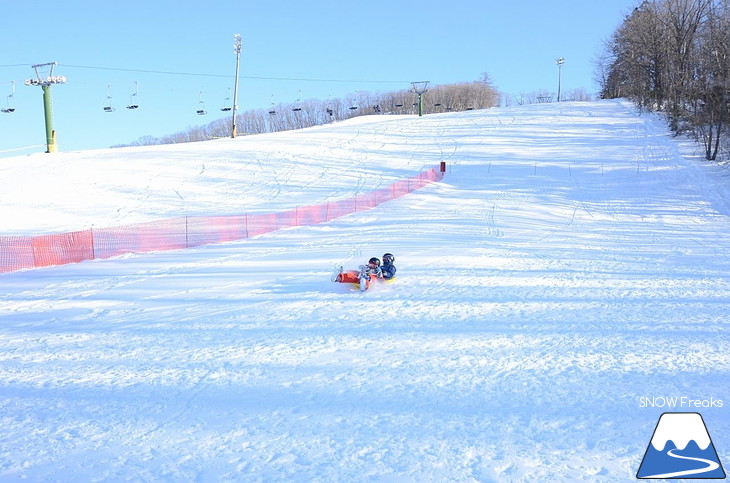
[0,101,730,482]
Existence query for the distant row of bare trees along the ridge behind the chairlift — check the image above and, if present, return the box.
[116,74,500,147]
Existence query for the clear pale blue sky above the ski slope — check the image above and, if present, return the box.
[0,0,639,157]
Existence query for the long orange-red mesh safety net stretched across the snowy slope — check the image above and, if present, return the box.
[0,163,445,273]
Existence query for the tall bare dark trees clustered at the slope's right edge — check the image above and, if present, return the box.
[596,0,730,161]
